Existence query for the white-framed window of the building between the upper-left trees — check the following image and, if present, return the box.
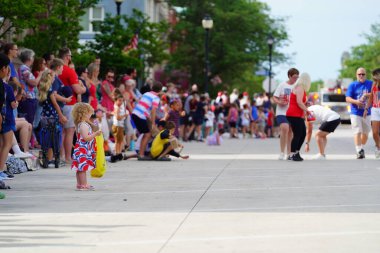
[80,7,104,33]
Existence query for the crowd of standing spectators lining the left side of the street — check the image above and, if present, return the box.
[0,43,275,192]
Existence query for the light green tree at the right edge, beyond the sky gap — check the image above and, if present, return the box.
[340,23,380,79]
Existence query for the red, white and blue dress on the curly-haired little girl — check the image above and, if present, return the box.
[71,122,96,171]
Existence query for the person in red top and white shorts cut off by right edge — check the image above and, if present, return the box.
[363,68,380,159]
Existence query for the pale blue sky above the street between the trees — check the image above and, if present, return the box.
[261,0,380,81]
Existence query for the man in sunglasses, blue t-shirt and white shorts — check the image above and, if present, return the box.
[346,68,372,159]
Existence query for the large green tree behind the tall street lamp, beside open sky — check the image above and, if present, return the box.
[169,0,288,94]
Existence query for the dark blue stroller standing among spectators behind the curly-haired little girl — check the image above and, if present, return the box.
[40,117,62,168]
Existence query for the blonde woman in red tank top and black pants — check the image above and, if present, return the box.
[286,73,311,161]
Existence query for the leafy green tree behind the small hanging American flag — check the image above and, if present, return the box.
[85,10,168,78]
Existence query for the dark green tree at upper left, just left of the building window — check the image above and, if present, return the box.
[17,0,99,55]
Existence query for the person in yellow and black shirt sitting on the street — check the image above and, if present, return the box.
[150,121,189,161]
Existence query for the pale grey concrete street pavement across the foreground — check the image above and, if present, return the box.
[0,125,380,253]
